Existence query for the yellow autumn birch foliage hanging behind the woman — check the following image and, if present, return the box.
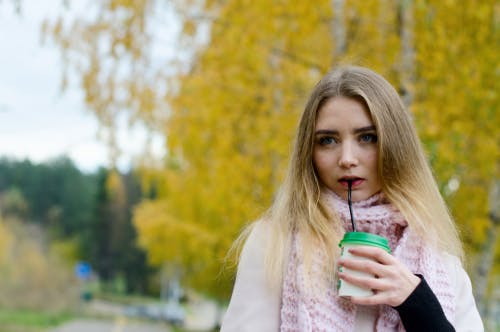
[43,0,500,306]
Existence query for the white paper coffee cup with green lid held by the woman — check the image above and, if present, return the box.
[337,232,391,297]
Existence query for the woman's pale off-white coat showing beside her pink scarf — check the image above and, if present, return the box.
[221,223,484,332]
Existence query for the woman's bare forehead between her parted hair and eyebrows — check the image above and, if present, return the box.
[316,97,373,129]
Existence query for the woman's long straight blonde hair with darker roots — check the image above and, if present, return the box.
[248,66,463,286]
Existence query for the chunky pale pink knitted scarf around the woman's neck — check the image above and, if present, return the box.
[280,191,455,332]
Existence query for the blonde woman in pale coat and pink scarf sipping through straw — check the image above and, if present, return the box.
[222,66,483,332]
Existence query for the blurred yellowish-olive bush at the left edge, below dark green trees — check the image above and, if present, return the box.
[0,216,77,311]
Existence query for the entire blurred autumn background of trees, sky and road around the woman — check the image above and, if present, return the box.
[0,0,500,332]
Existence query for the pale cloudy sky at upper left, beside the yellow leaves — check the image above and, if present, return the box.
[0,0,162,172]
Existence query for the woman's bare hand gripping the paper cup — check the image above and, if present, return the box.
[339,246,420,307]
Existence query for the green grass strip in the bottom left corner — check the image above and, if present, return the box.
[0,309,74,332]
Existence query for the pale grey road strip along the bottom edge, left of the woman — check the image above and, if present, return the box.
[50,317,171,332]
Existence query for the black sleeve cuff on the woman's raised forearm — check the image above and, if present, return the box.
[394,274,455,332]
